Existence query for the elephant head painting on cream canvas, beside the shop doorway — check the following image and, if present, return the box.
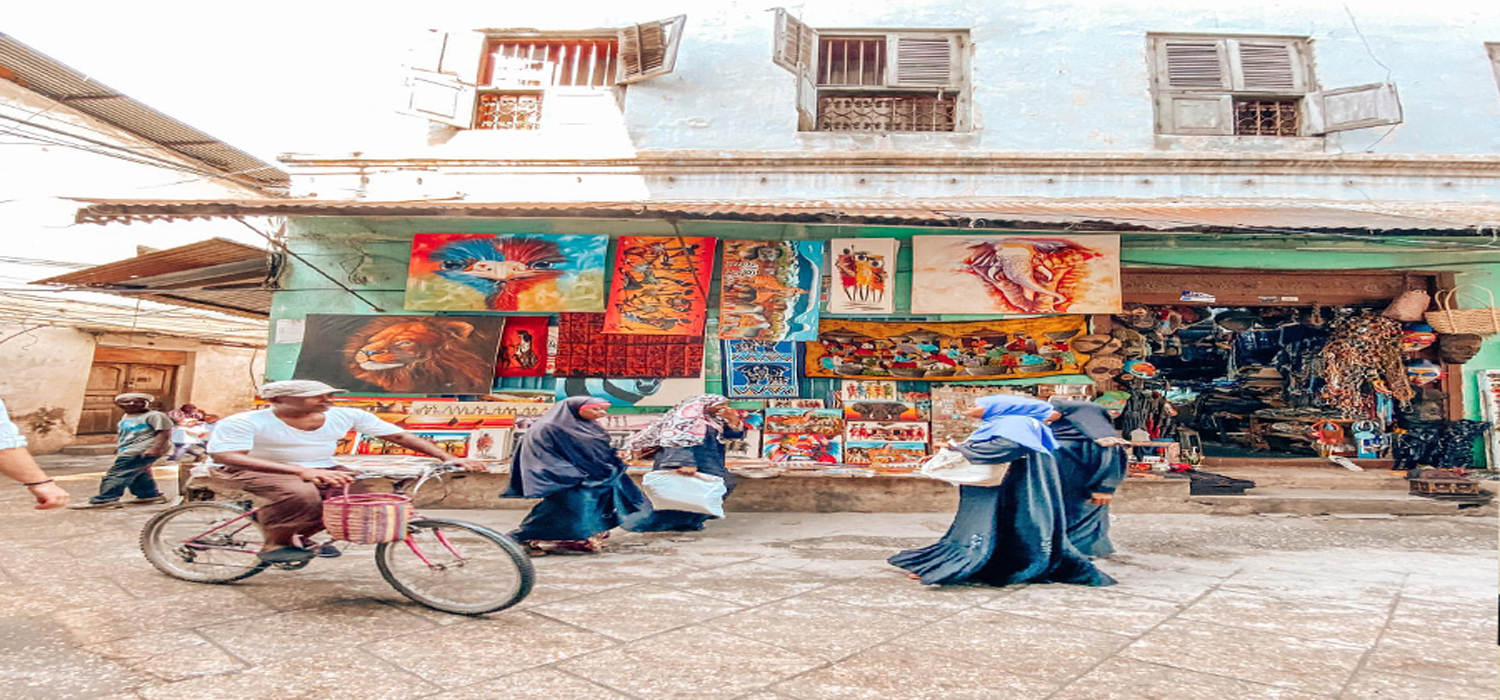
[912,235,1121,313]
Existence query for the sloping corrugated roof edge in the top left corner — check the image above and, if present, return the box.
[0,33,290,193]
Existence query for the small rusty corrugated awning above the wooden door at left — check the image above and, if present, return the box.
[33,238,278,319]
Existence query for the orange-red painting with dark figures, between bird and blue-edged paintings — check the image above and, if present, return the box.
[605,235,716,336]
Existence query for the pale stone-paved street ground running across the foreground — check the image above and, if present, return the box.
[0,460,1500,700]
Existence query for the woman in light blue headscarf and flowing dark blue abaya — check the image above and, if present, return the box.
[890,396,1115,586]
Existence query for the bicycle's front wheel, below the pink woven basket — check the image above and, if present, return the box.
[375,519,536,615]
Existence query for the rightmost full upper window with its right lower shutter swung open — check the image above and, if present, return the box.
[1148,34,1401,136]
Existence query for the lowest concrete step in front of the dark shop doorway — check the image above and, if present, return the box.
[1188,487,1496,516]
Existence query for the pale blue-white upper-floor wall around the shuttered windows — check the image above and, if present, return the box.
[375,0,1500,159]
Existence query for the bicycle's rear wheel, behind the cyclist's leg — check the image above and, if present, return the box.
[141,502,267,583]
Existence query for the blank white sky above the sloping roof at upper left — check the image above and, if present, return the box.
[0,0,1500,160]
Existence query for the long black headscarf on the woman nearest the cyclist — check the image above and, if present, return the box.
[504,396,626,498]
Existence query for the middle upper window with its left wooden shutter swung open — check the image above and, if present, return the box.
[773,16,969,132]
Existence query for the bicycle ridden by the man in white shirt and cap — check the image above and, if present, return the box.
[141,465,536,615]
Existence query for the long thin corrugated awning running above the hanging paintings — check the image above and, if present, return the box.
[67,198,1500,235]
